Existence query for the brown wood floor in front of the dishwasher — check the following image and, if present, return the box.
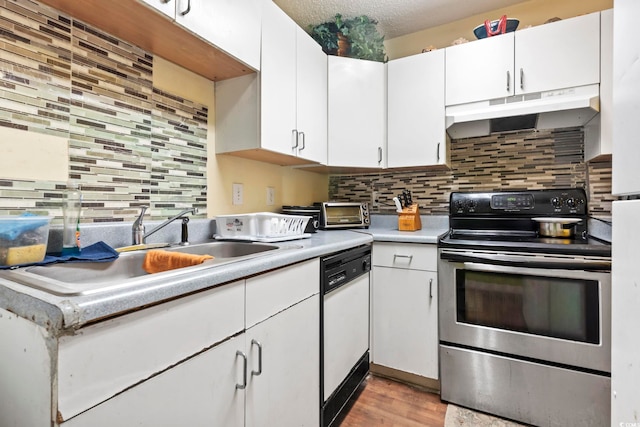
[340,375,447,427]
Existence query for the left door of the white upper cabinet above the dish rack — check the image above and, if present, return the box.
[260,1,297,155]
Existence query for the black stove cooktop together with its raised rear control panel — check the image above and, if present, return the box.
[439,188,611,256]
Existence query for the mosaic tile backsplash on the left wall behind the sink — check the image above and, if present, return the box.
[0,0,208,222]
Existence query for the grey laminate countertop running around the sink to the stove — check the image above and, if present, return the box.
[0,215,448,333]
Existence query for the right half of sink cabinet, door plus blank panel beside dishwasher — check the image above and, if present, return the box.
[246,259,320,427]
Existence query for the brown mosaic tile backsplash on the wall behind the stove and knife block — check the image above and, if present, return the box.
[329,128,614,217]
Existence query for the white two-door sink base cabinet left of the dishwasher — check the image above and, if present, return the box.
[56,259,320,427]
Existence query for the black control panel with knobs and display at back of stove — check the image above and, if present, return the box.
[449,188,587,217]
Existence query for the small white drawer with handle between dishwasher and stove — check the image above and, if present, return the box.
[372,242,438,271]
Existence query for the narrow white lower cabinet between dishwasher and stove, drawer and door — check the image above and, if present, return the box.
[371,242,438,379]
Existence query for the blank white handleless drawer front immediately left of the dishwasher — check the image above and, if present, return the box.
[246,258,320,329]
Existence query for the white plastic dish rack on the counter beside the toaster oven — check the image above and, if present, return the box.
[215,212,312,242]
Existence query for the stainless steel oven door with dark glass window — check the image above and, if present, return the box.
[438,248,611,373]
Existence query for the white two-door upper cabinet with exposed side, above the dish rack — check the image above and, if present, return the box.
[216,0,327,165]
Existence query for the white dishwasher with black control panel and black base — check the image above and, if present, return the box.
[320,245,371,427]
